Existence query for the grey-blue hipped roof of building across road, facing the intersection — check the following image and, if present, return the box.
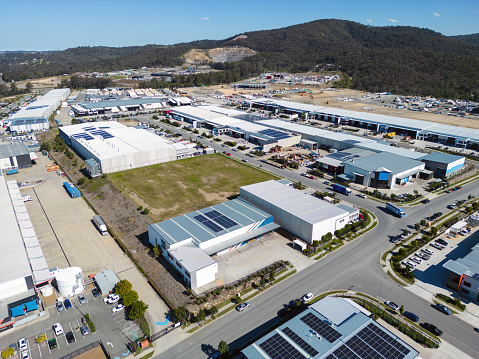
[344,152,424,174]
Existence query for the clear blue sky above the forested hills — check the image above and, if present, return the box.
[0,0,479,51]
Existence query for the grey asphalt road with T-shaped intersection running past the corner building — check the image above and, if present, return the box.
[133,117,479,359]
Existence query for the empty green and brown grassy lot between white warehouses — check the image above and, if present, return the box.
[107,154,277,222]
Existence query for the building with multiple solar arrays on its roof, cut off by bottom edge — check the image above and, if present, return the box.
[242,297,419,359]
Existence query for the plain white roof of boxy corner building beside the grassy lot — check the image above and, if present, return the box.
[240,180,349,224]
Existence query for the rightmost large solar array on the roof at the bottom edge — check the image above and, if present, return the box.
[327,323,410,359]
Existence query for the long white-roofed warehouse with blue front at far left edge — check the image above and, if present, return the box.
[0,173,51,328]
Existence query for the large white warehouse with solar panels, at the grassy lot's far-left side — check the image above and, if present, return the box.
[59,121,195,173]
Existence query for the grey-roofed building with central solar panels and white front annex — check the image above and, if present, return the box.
[148,198,280,290]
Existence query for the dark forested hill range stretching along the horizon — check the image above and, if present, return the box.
[0,20,479,99]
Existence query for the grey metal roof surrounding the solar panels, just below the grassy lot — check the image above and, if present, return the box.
[150,198,272,244]
